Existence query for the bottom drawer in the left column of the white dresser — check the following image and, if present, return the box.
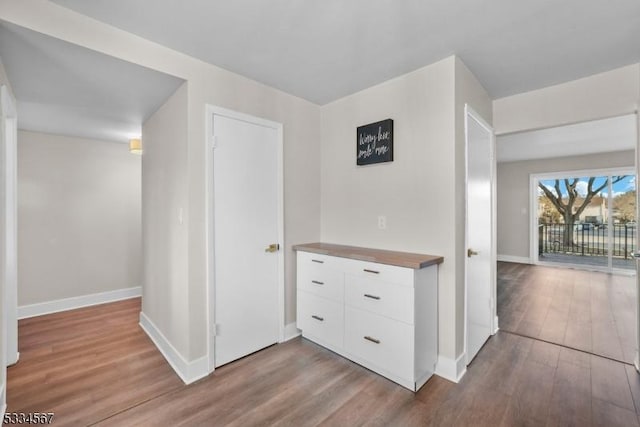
[297,290,344,349]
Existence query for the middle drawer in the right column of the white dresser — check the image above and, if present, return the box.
[345,275,414,324]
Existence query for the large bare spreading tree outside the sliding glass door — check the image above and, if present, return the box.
[538,175,626,246]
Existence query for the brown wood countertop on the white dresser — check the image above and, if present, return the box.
[293,242,444,270]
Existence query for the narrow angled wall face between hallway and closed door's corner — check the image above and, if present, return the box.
[142,83,189,353]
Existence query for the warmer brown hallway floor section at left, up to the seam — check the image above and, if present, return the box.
[7,298,183,426]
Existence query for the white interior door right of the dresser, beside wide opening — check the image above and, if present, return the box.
[465,107,496,364]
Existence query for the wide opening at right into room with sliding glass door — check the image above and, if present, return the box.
[498,115,638,367]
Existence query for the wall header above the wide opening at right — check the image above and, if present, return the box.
[493,64,640,134]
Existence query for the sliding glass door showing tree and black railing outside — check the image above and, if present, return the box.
[530,169,637,273]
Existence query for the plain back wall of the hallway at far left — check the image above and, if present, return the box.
[18,131,142,306]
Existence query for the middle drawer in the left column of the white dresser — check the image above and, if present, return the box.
[297,261,344,303]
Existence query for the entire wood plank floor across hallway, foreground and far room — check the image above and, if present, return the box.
[8,290,640,426]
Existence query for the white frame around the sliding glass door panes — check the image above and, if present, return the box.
[529,166,638,274]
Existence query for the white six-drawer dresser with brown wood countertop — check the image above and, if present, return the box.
[294,243,443,391]
